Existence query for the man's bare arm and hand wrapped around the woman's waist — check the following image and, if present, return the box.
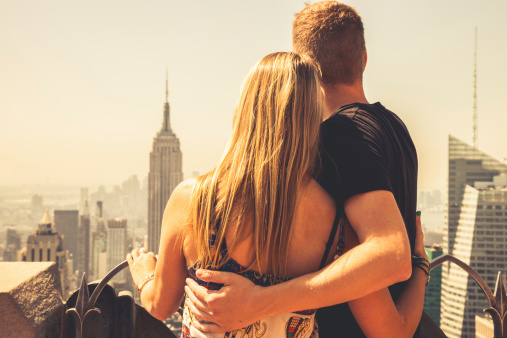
[185,190,412,332]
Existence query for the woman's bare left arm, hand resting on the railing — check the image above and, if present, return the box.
[129,181,193,320]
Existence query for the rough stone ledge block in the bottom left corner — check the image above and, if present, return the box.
[0,262,64,337]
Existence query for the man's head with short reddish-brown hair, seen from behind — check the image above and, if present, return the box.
[292,1,366,84]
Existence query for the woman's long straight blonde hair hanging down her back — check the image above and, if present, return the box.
[192,53,322,276]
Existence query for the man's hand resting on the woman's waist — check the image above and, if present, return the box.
[185,270,266,332]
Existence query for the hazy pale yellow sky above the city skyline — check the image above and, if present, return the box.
[0,0,507,189]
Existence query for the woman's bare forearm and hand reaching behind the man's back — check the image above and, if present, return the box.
[348,216,428,337]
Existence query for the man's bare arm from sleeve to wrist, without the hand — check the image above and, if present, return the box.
[264,191,412,313]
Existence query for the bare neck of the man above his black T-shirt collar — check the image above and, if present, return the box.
[321,81,368,120]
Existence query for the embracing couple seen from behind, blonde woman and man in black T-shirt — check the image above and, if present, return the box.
[127,1,428,337]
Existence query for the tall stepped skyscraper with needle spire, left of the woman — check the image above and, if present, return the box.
[148,75,183,253]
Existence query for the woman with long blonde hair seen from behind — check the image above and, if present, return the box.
[127,53,338,337]
